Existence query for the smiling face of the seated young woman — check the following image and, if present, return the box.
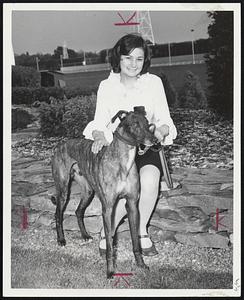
[120,48,144,77]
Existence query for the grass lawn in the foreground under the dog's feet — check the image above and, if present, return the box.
[11,227,232,289]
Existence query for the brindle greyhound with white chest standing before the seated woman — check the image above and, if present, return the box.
[52,106,157,278]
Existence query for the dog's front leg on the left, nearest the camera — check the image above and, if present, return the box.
[102,205,114,278]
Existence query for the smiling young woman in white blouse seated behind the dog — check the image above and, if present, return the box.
[83,34,177,256]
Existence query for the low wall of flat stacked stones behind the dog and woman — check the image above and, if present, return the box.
[11,157,233,248]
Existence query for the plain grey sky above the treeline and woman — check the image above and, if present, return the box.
[12,10,211,55]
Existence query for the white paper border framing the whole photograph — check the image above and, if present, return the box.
[3,3,241,297]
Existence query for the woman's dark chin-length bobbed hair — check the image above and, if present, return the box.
[110,33,151,74]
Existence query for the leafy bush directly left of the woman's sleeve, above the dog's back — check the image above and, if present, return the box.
[40,95,96,138]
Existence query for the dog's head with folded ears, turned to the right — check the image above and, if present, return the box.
[112,106,158,146]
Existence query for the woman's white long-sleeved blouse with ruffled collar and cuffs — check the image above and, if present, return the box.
[83,72,177,145]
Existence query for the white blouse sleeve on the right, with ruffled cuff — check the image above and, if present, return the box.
[154,76,177,145]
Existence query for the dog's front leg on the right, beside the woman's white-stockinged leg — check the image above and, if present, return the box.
[126,196,149,269]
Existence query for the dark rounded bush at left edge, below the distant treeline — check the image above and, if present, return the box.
[12,66,41,88]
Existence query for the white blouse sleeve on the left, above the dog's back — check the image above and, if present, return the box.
[83,81,113,143]
